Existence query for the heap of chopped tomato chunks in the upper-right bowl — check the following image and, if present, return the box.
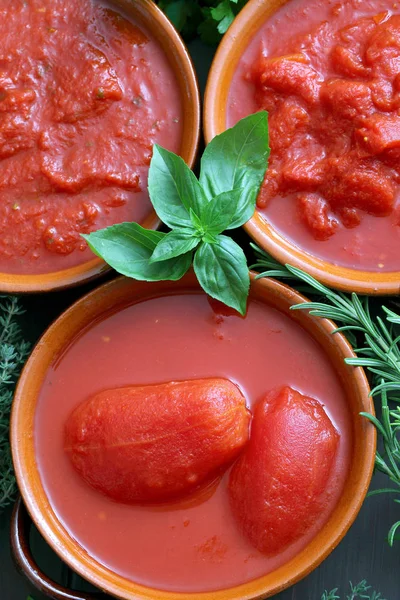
[250,4,400,241]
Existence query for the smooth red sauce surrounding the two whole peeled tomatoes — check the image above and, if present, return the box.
[35,294,352,592]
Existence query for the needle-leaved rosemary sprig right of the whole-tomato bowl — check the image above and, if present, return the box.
[251,244,400,544]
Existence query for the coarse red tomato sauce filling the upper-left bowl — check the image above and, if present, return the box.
[0,0,182,273]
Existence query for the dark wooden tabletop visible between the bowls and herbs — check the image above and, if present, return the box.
[0,42,400,600]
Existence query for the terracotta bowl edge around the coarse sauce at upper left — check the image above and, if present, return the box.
[0,0,200,294]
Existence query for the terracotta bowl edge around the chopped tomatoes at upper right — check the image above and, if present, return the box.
[204,0,400,294]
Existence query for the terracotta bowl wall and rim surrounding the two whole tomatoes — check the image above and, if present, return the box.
[11,273,376,600]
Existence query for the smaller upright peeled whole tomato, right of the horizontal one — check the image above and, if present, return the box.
[229,387,339,555]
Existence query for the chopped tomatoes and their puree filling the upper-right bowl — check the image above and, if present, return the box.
[228,0,400,271]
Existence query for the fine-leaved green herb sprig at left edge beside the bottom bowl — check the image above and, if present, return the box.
[0,297,29,512]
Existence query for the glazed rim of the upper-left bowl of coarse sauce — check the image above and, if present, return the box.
[0,0,201,294]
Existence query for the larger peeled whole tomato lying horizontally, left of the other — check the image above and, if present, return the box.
[64,379,250,503]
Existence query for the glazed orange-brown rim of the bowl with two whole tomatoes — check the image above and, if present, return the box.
[11,273,376,600]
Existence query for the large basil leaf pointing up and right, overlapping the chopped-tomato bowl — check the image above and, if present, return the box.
[200,111,269,204]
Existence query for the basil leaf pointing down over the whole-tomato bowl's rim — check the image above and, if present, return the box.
[193,235,250,315]
